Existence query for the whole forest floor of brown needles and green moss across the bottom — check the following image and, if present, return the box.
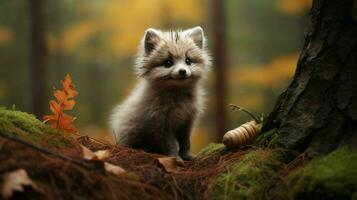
[0,108,357,199]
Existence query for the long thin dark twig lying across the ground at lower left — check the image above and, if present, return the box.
[0,132,97,169]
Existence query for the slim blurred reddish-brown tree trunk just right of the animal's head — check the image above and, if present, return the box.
[213,0,227,141]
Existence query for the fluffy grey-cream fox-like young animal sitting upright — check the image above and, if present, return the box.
[111,27,210,160]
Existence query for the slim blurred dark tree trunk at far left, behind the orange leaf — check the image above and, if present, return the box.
[30,0,46,117]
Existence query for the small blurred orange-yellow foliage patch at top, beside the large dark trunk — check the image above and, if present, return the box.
[277,0,312,15]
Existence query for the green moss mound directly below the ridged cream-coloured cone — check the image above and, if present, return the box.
[213,149,284,199]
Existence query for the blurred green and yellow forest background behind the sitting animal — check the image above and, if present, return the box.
[0,0,311,152]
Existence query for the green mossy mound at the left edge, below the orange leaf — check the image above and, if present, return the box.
[0,108,71,147]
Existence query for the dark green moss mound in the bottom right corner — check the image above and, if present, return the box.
[280,147,357,199]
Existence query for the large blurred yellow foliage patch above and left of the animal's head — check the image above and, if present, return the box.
[47,0,203,56]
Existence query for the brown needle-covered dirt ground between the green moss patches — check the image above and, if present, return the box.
[0,131,250,199]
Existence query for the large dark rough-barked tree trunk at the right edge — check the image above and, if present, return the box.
[263,0,357,157]
